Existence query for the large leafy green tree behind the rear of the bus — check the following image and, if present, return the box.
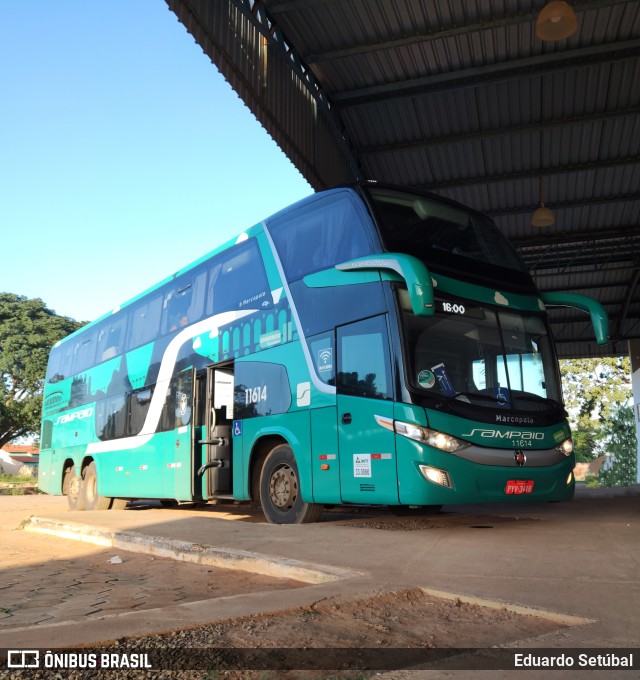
[0,293,83,447]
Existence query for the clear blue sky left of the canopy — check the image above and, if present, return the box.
[0,0,312,321]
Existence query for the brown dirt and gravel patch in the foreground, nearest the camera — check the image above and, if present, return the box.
[3,588,563,680]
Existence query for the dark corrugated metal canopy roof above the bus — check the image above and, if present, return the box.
[166,0,640,357]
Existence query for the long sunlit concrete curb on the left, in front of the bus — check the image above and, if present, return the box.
[20,516,363,584]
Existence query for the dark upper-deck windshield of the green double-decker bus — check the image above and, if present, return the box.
[365,186,533,288]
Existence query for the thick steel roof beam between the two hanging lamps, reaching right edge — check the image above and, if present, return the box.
[331,38,640,107]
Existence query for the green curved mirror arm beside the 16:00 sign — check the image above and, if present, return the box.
[336,253,435,316]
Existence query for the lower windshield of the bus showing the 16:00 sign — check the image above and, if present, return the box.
[400,290,562,414]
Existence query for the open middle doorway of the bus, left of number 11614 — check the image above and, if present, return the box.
[193,363,234,500]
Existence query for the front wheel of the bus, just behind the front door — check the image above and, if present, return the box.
[260,444,324,524]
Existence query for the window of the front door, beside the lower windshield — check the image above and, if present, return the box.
[337,316,393,399]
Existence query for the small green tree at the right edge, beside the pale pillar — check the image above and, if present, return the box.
[598,404,638,486]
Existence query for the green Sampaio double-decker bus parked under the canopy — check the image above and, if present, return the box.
[39,183,607,523]
